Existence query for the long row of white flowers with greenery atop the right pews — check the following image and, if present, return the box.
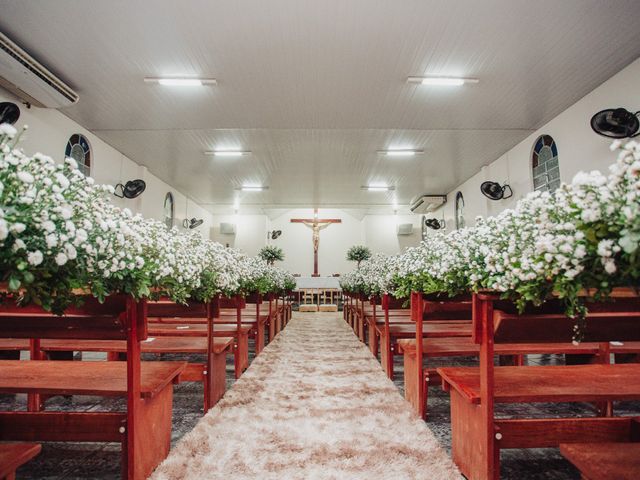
[341,141,640,341]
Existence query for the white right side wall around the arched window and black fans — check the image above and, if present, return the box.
[435,55,640,230]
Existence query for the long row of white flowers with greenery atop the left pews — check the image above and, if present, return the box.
[0,124,295,312]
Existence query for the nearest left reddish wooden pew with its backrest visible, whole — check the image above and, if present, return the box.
[0,295,186,480]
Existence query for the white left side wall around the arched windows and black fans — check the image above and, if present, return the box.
[0,88,212,237]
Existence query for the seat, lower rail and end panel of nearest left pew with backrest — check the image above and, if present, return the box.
[0,360,186,479]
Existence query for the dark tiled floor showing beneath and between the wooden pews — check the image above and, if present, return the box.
[0,316,640,480]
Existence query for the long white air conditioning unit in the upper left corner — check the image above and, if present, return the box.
[0,33,79,108]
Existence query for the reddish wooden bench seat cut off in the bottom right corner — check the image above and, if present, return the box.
[560,440,640,480]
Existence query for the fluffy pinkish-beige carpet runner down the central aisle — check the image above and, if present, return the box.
[152,313,461,480]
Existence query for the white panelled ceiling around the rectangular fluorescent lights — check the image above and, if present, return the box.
[0,0,640,211]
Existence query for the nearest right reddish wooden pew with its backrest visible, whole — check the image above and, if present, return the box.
[438,292,640,480]
